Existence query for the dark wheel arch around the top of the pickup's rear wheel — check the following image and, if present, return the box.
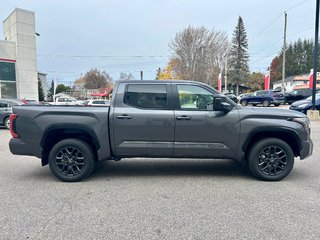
[40,124,101,166]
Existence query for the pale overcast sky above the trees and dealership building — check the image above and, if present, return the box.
[0,0,316,85]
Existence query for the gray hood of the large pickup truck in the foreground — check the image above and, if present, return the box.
[239,107,306,119]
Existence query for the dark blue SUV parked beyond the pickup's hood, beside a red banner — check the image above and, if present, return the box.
[240,90,285,107]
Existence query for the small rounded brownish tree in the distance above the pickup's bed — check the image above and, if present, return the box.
[83,69,112,89]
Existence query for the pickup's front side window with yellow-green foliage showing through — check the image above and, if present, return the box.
[177,85,213,111]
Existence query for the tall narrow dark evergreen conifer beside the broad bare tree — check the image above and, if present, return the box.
[228,16,249,95]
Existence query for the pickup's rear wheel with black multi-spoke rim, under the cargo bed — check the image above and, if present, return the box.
[49,138,95,182]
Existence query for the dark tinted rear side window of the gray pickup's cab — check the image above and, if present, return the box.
[123,84,168,109]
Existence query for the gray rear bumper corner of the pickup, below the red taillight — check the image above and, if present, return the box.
[9,138,41,158]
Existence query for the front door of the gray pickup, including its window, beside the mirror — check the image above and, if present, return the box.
[172,84,240,158]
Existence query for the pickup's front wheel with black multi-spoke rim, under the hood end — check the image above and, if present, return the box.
[248,138,294,181]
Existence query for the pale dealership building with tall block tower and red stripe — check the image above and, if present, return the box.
[0,8,38,100]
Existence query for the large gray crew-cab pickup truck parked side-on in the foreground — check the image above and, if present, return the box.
[9,80,313,181]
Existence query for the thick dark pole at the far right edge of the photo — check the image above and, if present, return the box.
[312,0,319,110]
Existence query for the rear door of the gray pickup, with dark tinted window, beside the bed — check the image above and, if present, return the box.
[111,83,174,157]
